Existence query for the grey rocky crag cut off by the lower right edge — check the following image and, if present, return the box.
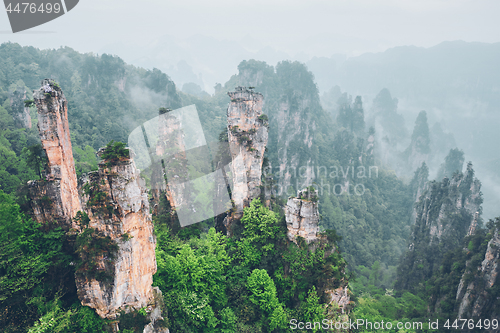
[457,228,500,324]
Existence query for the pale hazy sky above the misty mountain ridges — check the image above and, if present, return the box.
[0,0,500,56]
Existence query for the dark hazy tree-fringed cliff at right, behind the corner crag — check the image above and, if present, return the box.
[396,163,482,290]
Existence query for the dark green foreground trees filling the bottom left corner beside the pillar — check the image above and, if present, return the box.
[0,191,104,333]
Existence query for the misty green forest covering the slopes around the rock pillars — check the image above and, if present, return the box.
[0,43,500,333]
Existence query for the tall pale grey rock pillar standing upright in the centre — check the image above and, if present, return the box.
[227,87,268,218]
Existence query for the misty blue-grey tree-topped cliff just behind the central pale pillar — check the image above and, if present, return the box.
[230,60,328,196]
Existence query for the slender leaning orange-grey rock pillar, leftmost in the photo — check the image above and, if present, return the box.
[29,80,82,229]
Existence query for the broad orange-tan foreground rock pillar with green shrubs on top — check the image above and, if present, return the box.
[76,150,166,332]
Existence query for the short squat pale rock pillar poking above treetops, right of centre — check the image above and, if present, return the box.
[285,189,319,243]
